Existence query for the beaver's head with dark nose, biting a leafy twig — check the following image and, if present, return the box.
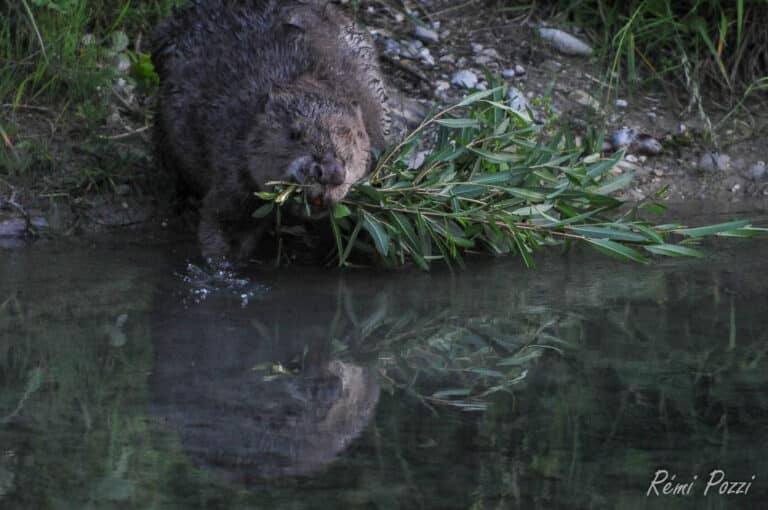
[249,85,371,205]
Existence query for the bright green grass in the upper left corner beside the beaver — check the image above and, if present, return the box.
[0,0,181,105]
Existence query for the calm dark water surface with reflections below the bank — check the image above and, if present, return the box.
[0,213,768,509]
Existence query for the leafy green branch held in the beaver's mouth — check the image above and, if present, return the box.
[266,82,768,269]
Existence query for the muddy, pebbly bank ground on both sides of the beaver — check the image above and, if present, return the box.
[0,0,768,240]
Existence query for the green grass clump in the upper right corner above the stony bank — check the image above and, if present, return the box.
[544,0,768,95]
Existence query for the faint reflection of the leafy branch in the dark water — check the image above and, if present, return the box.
[330,296,581,411]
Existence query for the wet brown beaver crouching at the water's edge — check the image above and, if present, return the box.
[152,0,391,258]
